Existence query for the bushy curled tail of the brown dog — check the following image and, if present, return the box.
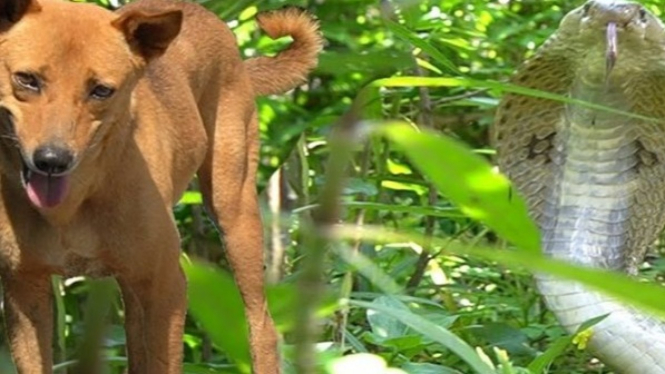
[245,7,323,96]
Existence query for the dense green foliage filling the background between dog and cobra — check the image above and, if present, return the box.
[0,0,665,374]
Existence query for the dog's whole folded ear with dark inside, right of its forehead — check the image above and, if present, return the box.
[112,10,182,61]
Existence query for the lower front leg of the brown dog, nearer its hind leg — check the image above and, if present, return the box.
[118,237,187,374]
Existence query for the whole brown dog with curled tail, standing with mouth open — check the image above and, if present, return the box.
[0,0,321,374]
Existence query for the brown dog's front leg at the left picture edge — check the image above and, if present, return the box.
[2,272,53,374]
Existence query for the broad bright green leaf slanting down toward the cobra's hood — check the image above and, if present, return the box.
[377,123,540,253]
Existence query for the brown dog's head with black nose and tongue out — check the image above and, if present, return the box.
[0,0,182,208]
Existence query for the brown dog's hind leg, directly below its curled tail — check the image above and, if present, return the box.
[199,81,280,374]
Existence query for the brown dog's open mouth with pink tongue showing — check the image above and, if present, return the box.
[21,158,69,208]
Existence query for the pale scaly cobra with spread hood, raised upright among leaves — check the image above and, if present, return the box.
[493,0,665,374]
